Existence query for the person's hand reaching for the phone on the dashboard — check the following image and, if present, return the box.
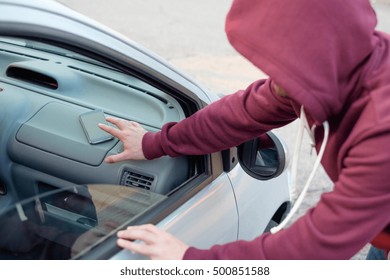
[99,117,147,163]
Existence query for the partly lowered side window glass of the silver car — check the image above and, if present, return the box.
[0,185,166,259]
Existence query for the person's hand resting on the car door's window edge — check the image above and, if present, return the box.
[117,224,189,260]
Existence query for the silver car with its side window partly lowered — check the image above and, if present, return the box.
[0,0,290,259]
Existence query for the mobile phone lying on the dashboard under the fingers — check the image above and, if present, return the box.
[79,110,114,144]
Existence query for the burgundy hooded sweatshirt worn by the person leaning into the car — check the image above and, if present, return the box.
[143,0,390,259]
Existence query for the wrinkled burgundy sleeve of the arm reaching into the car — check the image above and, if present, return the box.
[142,79,296,159]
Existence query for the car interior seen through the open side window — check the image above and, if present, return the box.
[0,37,204,259]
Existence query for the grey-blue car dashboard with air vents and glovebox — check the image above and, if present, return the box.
[0,38,189,205]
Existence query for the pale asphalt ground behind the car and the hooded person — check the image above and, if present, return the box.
[60,0,390,259]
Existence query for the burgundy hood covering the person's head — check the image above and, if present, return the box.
[225,0,378,123]
